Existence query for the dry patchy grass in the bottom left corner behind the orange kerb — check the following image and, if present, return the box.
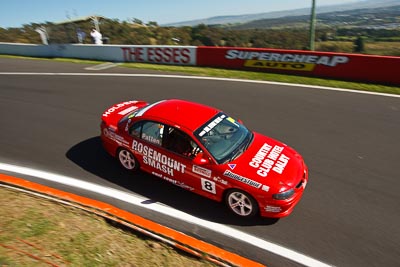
[0,187,216,267]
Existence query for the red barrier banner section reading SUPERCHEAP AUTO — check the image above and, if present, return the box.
[197,46,400,85]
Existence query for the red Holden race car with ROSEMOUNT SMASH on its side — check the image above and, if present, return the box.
[101,99,308,218]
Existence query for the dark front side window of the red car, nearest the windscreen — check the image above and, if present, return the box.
[164,127,201,158]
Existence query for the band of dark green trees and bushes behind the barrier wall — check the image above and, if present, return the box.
[0,19,400,55]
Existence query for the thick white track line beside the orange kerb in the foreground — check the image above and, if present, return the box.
[0,163,331,267]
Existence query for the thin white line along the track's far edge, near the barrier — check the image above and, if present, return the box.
[0,72,400,98]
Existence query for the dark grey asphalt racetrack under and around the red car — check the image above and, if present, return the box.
[0,58,400,267]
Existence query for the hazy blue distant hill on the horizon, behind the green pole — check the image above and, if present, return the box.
[162,0,400,27]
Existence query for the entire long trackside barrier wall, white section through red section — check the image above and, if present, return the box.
[0,43,400,85]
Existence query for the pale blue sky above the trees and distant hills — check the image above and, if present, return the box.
[0,0,357,28]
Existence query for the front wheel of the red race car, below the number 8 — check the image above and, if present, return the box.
[225,189,258,218]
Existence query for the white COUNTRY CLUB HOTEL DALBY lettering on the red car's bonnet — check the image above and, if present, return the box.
[249,143,290,177]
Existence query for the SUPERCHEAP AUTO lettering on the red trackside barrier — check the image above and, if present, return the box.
[225,50,350,71]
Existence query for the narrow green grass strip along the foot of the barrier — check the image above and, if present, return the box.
[1,56,400,95]
